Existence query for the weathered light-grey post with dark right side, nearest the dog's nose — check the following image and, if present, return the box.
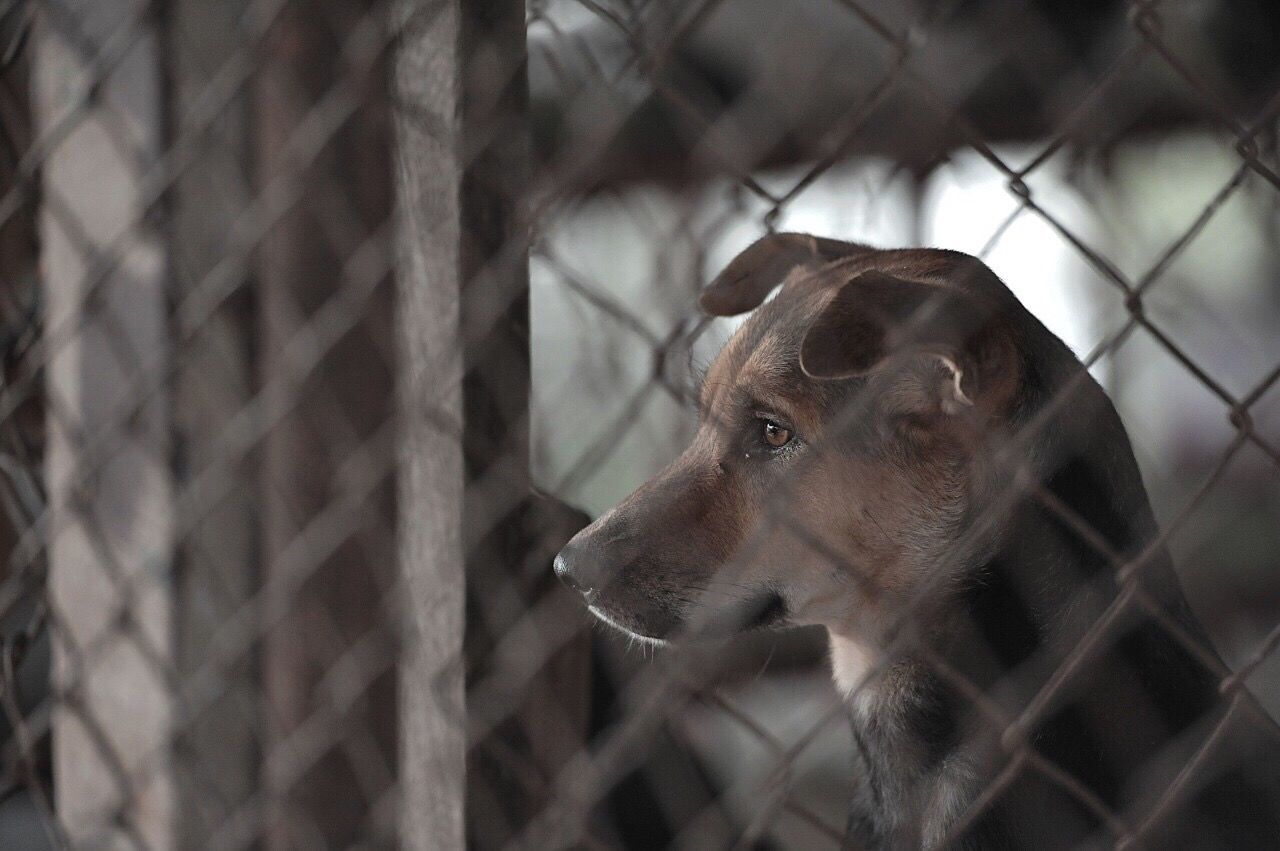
[396,0,588,847]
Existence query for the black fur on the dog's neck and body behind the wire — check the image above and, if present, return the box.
[849,273,1280,848]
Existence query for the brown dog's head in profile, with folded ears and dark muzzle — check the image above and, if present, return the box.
[556,234,1023,640]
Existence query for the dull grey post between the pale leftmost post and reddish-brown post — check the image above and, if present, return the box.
[164,0,261,848]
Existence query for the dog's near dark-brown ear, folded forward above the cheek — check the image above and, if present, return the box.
[800,271,1018,413]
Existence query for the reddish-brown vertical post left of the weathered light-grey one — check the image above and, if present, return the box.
[253,0,396,847]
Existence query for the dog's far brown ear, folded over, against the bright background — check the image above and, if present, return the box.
[699,233,874,316]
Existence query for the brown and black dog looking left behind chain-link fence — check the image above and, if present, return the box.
[554,233,1280,848]
